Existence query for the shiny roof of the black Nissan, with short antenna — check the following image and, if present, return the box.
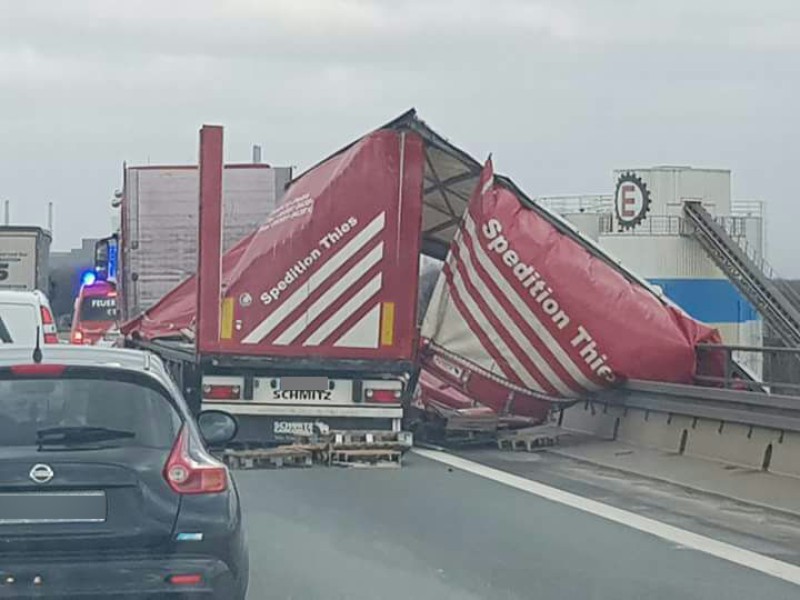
[0,344,159,375]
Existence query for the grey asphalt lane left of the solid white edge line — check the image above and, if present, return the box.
[235,456,800,600]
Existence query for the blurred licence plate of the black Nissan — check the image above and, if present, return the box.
[0,492,107,525]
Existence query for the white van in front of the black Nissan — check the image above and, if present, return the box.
[0,290,58,347]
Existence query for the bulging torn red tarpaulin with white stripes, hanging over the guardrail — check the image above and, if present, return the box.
[422,161,720,415]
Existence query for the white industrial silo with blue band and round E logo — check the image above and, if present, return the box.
[541,166,764,376]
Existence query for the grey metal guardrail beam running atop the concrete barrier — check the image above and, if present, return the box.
[597,381,800,432]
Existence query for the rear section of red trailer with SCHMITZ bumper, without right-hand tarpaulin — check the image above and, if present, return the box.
[123,119,432,443]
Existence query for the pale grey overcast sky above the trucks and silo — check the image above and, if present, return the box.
[0,0,800,276]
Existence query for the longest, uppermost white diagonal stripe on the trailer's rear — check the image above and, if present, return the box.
[242,212,386,344]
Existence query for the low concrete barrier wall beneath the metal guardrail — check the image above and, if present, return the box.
[561,402,800,477]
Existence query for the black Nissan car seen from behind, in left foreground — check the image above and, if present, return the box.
[0,346,248,600]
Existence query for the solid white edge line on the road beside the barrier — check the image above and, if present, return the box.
[412,448,800,585]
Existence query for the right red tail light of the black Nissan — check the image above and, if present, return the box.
[164,426,228,494]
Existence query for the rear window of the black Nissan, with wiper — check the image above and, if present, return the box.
[0,371,181,449]
